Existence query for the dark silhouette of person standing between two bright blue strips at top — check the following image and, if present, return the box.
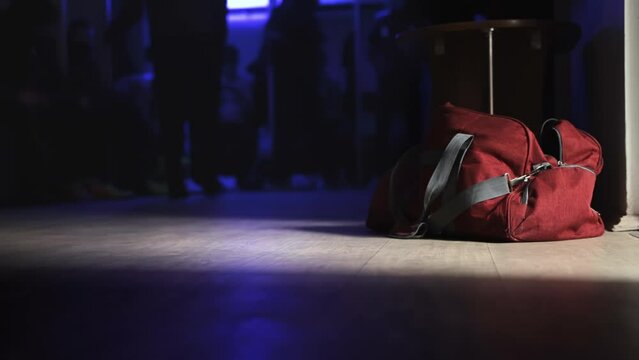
[252,0,324,184]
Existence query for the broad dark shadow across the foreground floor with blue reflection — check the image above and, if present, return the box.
[0,269,639,359]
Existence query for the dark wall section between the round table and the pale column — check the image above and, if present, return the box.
[555,0,626,227]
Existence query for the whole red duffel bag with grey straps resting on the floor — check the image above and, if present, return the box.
[366,104,604,241]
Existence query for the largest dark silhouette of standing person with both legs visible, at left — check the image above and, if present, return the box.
[107,0,227,198]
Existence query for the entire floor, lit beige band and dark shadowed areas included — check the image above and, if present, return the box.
[0,192,639,359]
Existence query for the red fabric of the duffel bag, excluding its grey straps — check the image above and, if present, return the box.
[367,104,604,241]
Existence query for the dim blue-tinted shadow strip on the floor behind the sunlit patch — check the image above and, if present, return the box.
[0,190,370,221]
